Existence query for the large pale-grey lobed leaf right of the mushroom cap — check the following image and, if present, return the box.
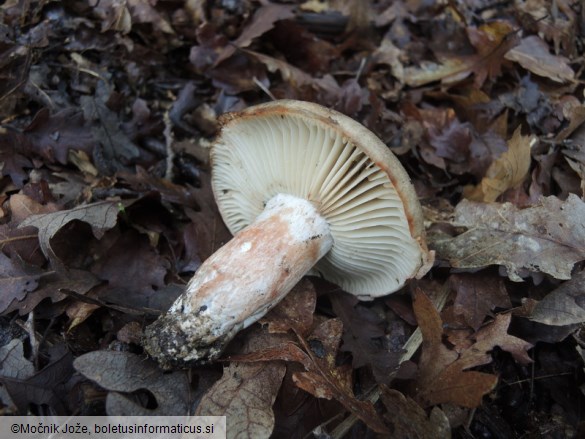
[429,194,585,282]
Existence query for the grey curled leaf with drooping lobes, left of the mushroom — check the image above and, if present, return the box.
[19,201,120,267]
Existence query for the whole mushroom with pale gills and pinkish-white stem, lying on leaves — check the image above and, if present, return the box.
[145,100,433,368]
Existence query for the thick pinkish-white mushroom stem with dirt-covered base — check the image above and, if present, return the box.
[145,194,333,367]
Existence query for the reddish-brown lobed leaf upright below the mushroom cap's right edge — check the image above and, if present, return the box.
[413,288,498,408]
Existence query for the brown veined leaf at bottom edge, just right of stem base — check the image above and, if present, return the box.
[195,361,286,439]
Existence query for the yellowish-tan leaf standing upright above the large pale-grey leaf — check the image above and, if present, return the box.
[463,127,538,203]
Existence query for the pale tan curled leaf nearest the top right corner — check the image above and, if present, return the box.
[505,35,575,82]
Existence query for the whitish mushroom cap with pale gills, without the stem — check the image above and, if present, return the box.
[211,100,432,300]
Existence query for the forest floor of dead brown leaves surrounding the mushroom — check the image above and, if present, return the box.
[0,0,585,438]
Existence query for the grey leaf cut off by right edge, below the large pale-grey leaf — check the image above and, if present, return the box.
[530,271,585,326]
